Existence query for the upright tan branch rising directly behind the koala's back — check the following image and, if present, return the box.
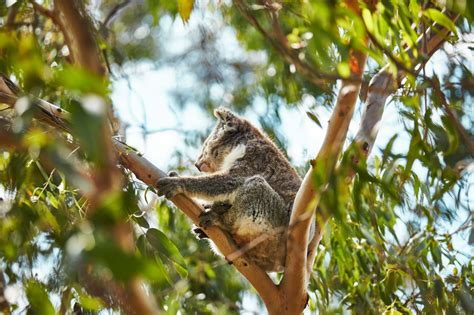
[280,1,368,314]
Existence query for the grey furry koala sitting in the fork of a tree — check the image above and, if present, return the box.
[157,107,301,272]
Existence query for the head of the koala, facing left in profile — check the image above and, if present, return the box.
[194,107,252,173]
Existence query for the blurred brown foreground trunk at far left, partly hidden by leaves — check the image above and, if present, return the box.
[4,0,158,314]
